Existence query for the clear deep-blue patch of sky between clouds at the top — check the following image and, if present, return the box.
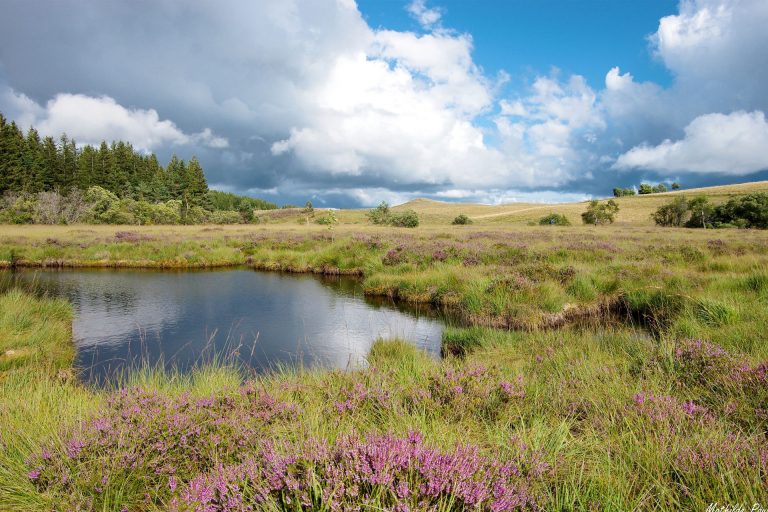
[357,0,678,87]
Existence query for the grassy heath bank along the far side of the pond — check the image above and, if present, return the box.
[0,225,768,332]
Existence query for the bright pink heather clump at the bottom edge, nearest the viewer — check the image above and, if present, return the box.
[170,433,536,512]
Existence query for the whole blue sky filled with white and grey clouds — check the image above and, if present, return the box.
[0,0,768,207]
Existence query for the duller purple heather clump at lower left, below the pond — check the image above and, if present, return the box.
[29,385,296,506]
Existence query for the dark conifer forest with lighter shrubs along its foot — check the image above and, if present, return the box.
[0,113,277,224]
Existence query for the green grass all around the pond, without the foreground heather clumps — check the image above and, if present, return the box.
[0,207,768,510]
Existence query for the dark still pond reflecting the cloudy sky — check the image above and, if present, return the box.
[6,269,446,382]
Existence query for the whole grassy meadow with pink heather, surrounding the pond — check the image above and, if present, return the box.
[0,182,768,511]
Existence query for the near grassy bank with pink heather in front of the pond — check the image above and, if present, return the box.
[0,286,768,511]
